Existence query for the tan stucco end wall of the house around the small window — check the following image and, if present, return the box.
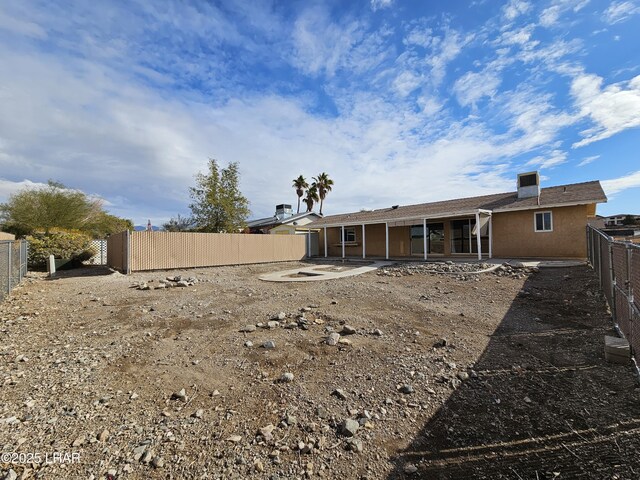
[493,205,595,258]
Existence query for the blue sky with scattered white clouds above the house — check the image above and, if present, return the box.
[0,0,640,224]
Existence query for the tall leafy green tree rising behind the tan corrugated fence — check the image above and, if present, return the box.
[189,159,249,233]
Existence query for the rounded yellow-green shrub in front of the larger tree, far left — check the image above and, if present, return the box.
[26,230,96,268]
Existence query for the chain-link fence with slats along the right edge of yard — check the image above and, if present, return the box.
[587,227,640,359]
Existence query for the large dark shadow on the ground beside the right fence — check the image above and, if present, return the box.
[389,267,640,480]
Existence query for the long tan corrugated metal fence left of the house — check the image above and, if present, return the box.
[107,231,307,272]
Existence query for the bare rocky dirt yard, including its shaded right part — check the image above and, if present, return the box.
[0,263,640,480]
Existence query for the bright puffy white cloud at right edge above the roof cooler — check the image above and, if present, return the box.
[571,73,640,148]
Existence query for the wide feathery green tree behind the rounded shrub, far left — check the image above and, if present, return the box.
[0,180,131,237]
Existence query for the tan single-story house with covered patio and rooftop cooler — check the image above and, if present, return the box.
[306,172,607,260]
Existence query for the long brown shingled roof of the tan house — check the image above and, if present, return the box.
[307,181,607,228]
